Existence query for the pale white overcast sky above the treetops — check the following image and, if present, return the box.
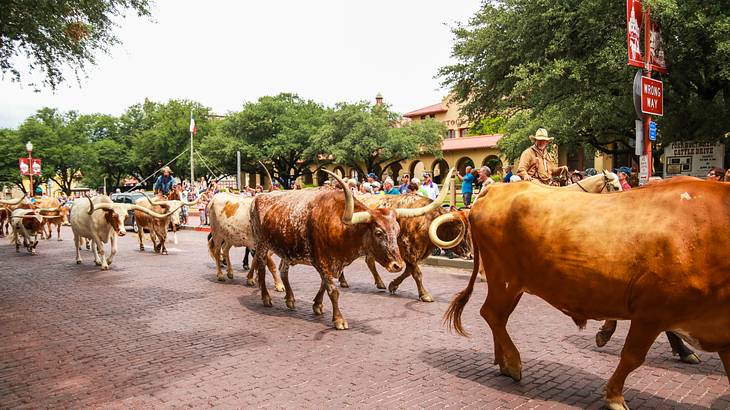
[0,0,481,128]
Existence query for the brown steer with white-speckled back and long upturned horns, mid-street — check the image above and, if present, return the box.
[251,170,453,329]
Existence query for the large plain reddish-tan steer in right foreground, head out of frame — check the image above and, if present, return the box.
[444,177,730,409]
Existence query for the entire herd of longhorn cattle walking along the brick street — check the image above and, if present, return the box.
[0,170,730,409]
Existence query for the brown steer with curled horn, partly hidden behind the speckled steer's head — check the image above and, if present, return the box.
[340,193,471,302]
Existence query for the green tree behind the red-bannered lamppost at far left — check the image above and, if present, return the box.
[18,108,94,195]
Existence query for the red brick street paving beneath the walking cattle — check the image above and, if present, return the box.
[0,227,730,409]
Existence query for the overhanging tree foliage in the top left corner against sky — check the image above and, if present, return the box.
[0,0,150,89]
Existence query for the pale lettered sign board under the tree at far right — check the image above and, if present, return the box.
[664,142,725,178]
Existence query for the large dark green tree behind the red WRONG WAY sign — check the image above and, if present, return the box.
[439,0,730,163]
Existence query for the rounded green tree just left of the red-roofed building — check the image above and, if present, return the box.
[315,102,446,175]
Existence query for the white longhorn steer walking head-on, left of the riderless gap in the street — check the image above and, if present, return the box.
[71,195,174,270]
